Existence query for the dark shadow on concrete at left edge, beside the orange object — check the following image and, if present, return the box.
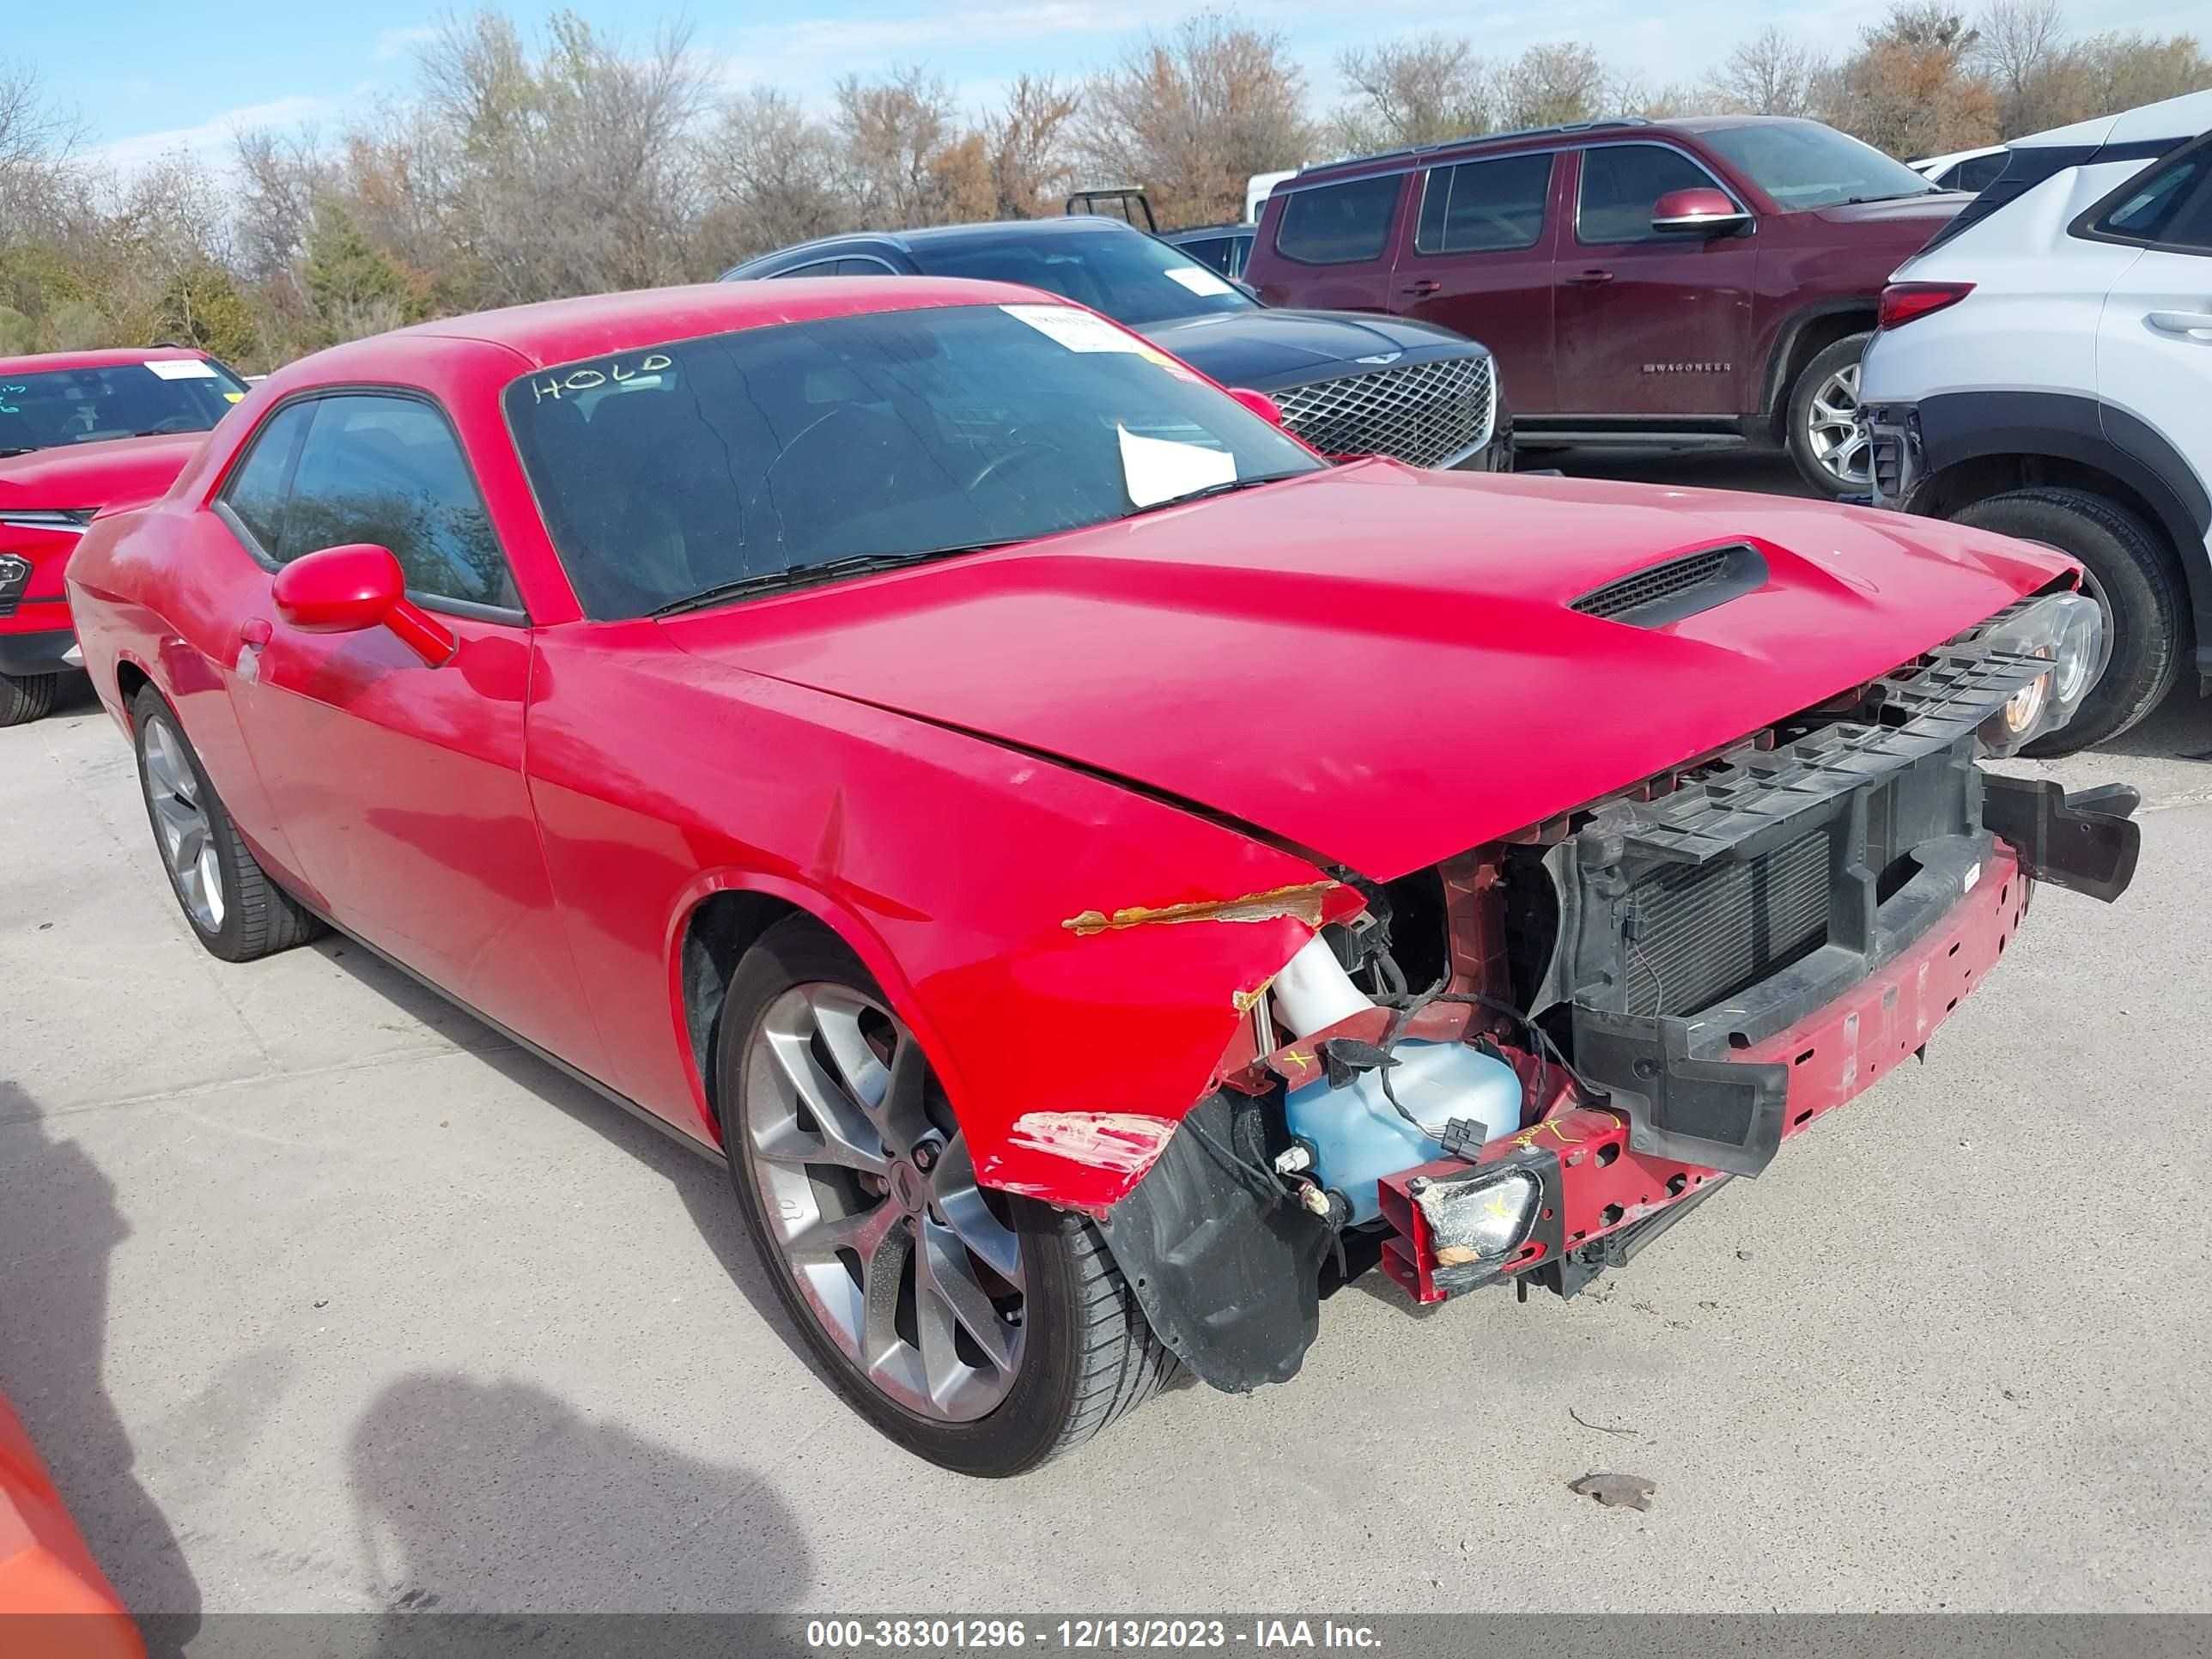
[0,1079,201,1655]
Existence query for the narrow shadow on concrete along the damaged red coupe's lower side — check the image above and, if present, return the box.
[310,933,830,1385]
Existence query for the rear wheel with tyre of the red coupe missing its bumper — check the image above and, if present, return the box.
[131,686,323,963]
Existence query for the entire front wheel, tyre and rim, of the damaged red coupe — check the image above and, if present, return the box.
[714,918,1172,1475]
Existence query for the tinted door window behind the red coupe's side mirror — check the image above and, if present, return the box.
[283,394,520,611]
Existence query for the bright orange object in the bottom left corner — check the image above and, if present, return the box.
[0,1398,146,1659]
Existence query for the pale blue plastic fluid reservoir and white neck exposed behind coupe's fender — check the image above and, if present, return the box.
[1274,936,1522,1224]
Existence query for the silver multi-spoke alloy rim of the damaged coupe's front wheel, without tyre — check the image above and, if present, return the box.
[744,980,1024,1422]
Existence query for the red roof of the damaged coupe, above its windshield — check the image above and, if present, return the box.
[270,276,1066,389]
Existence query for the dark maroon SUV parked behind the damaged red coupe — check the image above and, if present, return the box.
[1245,115,1969,495]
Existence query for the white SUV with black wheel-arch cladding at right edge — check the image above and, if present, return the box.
[1860,91,2212,754]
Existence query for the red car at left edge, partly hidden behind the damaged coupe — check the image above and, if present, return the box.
[0,347,246,726]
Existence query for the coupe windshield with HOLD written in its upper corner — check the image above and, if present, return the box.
[507,303,1322,617]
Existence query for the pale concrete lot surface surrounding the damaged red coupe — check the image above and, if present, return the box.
[0,467,2212,1613]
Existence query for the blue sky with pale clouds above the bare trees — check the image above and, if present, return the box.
[17,0,2203,170]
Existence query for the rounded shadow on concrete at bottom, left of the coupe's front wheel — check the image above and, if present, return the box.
[331,1371,811,1652]
